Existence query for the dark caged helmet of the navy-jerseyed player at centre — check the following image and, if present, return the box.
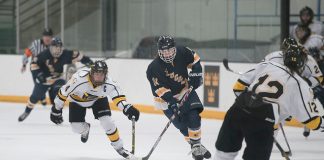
[157,36,176,63]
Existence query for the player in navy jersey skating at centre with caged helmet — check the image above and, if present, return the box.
[146,36,211,160]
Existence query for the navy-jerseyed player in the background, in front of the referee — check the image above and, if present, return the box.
[18,37,92,122]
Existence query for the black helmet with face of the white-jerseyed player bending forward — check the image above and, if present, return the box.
[90,60,108,86]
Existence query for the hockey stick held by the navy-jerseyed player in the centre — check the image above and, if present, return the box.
[139,87,193,160]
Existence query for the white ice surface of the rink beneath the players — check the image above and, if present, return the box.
[0,103,324,160]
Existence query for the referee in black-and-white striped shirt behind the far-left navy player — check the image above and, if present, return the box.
[21,28,53,106]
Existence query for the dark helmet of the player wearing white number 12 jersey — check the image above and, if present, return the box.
[283,45,307,73]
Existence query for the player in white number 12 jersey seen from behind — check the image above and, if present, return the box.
[215,45,324,160]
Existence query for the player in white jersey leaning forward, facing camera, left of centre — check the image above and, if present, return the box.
[50,61,140,158]
